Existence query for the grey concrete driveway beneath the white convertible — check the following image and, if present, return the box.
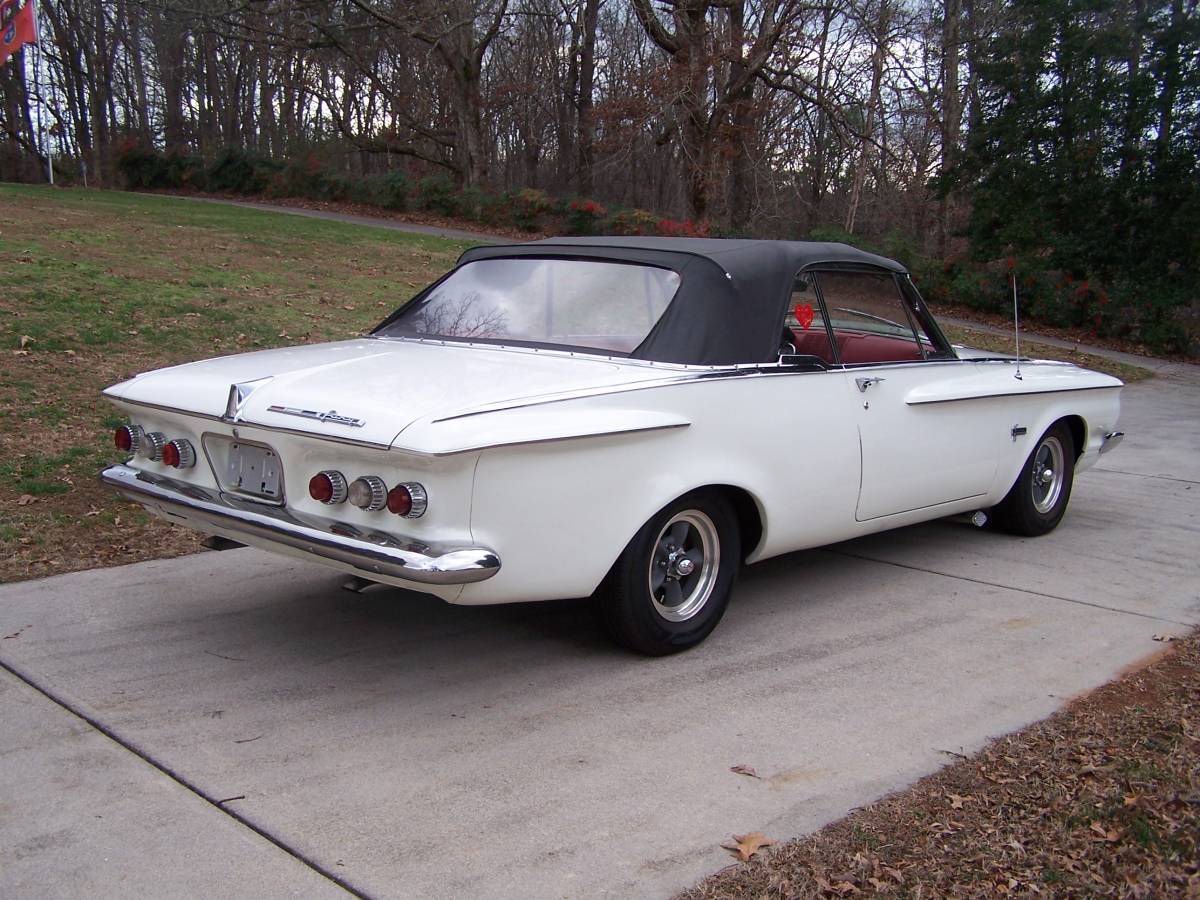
[0,367,1200,898]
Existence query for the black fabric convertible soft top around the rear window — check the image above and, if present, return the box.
[458,238,907,365]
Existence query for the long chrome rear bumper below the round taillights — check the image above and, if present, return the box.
[100,466,500,584]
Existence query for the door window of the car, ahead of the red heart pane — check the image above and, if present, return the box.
[816,271,934,366]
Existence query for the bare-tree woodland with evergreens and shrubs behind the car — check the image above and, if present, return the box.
[0,0,1200,350]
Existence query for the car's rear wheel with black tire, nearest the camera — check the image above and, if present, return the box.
[595,491,742,656]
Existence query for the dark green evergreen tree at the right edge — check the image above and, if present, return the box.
[955,0,1200,343]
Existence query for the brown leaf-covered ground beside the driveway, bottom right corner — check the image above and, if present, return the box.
[682,635,1200,900]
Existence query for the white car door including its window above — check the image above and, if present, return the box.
[814,271,998,522]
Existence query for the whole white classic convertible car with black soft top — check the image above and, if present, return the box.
[102,238,1122,654]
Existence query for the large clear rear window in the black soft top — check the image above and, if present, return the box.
[376,257,679,353]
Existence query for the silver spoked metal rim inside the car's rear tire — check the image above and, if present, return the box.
[649,509,721,622]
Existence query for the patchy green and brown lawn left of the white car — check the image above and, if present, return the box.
[0,185,468,582]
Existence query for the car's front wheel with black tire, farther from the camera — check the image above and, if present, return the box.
[990,422,1075,538]
